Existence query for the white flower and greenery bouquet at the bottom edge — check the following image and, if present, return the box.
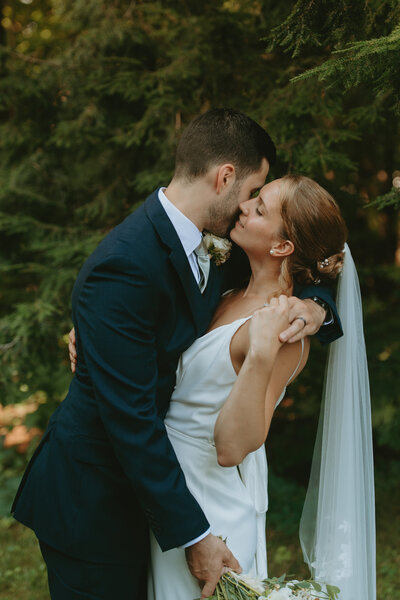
[198,571,340,600]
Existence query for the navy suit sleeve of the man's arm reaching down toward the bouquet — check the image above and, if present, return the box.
[74,256,209,550]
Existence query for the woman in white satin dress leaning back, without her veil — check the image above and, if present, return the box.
[148,175,354,600]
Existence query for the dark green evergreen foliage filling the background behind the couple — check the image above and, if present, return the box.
[0,0,400,597]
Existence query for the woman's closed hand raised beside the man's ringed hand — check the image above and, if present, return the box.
[249,295,289,357]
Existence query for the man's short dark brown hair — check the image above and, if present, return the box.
[175,108,276,180]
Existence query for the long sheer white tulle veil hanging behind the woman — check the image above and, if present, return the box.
[300,244,376,600]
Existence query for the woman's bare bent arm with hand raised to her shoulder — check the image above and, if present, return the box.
[214,296,309,467]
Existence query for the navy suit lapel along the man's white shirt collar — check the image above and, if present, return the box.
[144,190,208,332]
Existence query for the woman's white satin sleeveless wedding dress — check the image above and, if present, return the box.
[148,317,304,600]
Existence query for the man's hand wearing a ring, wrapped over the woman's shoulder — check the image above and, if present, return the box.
[279,296,326,344]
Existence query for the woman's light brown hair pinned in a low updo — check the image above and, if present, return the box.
[280,175,347,285]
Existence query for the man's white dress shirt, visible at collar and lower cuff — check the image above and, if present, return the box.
[158,188,211,548]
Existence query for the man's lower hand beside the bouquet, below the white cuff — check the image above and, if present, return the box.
[185,533,242,598]
